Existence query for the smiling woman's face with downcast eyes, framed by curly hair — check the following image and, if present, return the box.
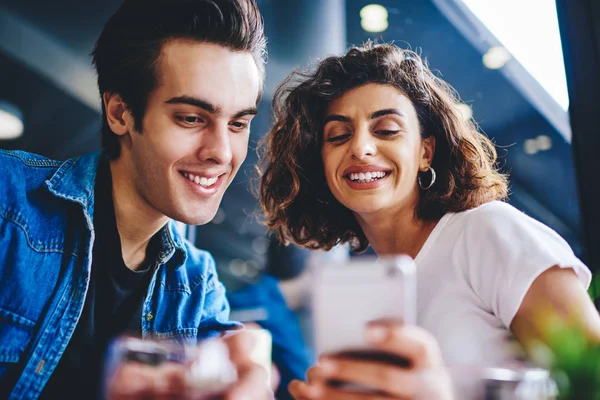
[321,83,435,215]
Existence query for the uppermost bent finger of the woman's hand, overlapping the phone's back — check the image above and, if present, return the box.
[367,321,443,369]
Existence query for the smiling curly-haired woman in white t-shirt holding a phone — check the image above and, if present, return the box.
[260,43,600,399]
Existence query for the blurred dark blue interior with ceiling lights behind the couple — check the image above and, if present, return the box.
[0,0,593,396]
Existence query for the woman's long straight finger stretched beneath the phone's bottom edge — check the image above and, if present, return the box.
[318,358,421,397]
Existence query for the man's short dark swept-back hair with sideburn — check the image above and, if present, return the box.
[92,0,266,159]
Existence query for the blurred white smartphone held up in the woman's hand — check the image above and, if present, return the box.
[311,255,417,364]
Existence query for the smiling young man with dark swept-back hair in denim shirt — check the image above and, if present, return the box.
[0,0,272,399]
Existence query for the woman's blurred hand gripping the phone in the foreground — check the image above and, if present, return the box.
[289,322,454,400]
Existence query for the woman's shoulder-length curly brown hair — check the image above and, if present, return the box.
[258,43,508,251]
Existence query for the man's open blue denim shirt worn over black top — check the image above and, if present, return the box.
[0,150,237,399]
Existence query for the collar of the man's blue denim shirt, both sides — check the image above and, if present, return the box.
[46,151,187,265]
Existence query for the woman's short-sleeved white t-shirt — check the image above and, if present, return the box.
[415,201,591,366]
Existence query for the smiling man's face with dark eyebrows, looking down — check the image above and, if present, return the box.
[120,40,260,225]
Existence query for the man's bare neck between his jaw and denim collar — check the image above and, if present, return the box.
[110,160,168,271]
